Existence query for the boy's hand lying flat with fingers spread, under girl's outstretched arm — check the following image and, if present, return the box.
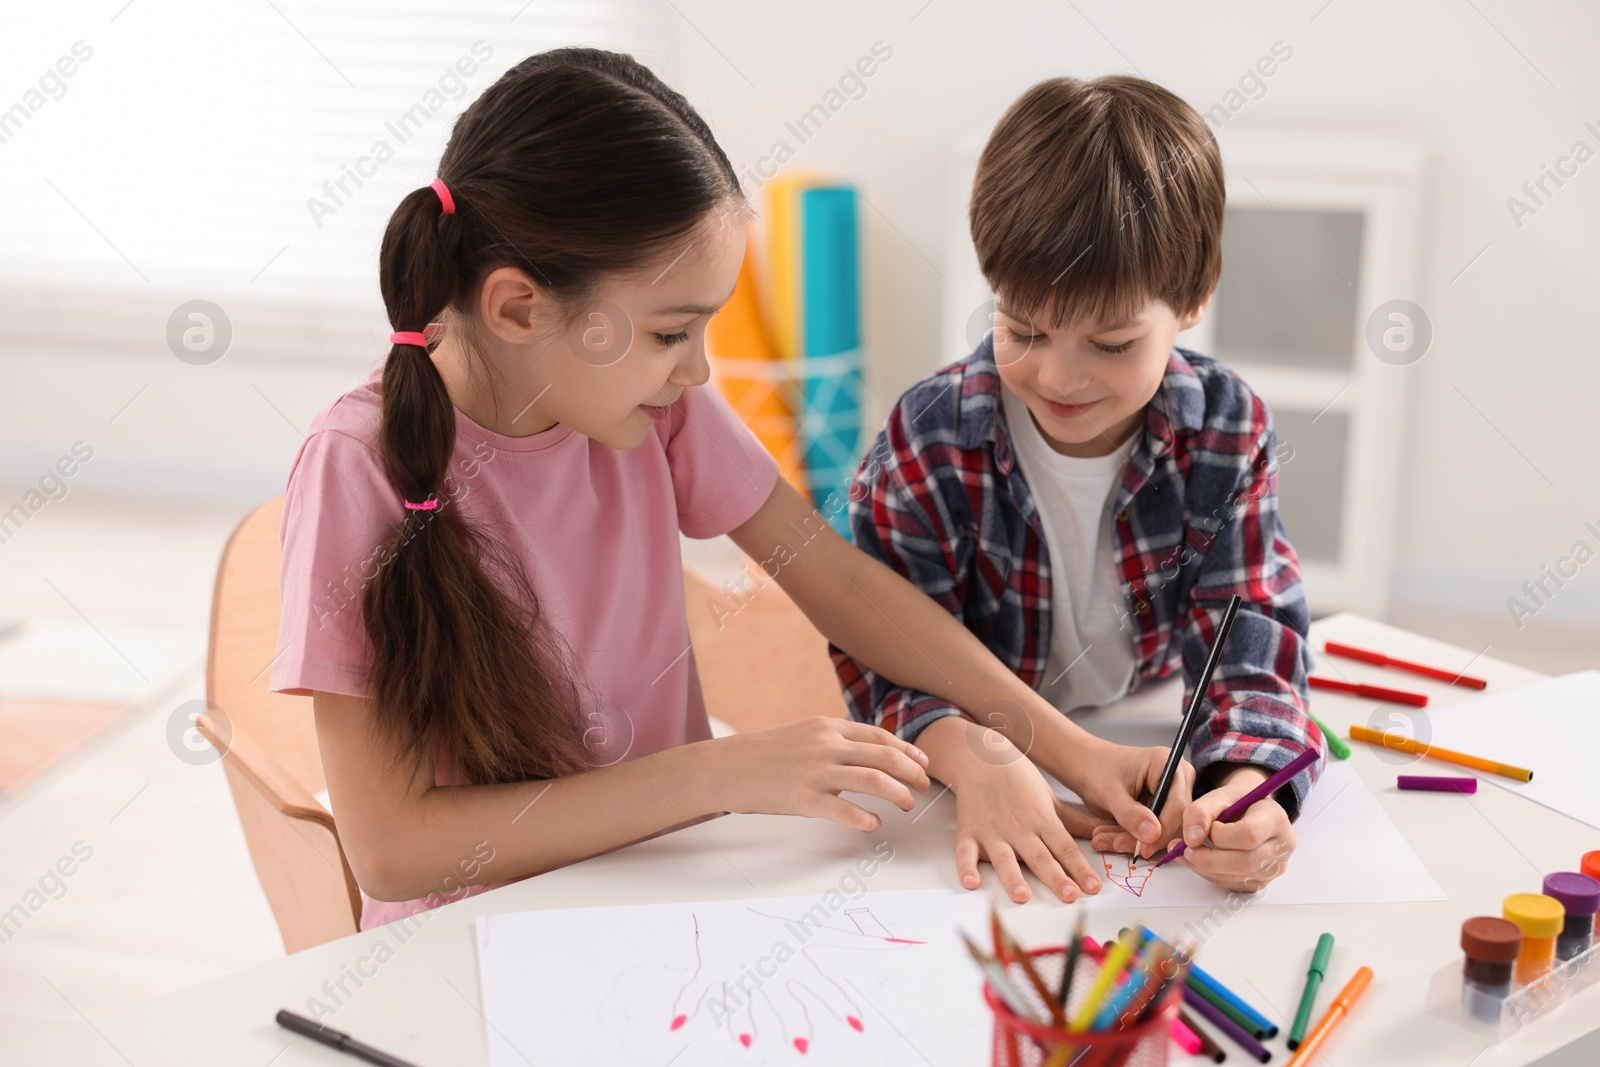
[917,717,1101,904]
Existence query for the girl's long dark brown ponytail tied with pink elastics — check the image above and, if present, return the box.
[363,189,589,784]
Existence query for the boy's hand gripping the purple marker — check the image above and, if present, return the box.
[1168,763,1296,893]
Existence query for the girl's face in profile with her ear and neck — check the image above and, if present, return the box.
[434,205,746,450]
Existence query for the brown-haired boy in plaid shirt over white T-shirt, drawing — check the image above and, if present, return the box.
[829,75,1322,891]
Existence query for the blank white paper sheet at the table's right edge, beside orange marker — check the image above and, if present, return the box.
[1416,670,1600,827]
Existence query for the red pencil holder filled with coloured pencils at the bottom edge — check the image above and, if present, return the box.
[984,945,1182,1067]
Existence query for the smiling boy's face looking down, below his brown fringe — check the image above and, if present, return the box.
[994,294,1211,456]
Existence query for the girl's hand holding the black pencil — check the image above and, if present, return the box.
[1061,741,1196,857]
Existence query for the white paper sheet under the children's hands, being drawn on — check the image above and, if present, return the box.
[1053,720,1446,909]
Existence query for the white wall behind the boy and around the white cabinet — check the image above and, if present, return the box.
[656,0,1600,619]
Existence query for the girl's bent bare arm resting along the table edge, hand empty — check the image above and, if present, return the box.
[314,691,928,901]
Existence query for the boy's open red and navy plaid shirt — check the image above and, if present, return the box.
[829,341,1322,817]
